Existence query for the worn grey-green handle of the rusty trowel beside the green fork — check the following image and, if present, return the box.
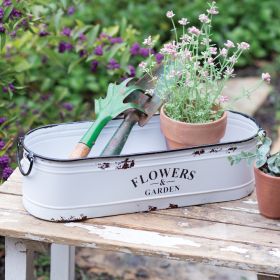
[101,111,139,156]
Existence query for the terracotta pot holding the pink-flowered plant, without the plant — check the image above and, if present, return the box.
[160,106,227,149]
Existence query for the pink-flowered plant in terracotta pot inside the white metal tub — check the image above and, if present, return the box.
[139,2,270,149]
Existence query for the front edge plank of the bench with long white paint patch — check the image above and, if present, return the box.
[1,210,280,274]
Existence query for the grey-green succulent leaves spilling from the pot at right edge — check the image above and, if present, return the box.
[228,131,280,177]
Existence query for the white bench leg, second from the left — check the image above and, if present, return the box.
[51,244,75,280]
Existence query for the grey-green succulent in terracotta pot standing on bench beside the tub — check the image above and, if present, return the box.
[229,131,280,219]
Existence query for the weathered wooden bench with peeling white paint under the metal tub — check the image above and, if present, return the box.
[0,170,280,280]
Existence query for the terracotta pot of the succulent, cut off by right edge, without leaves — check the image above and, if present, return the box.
[254,167,280,219]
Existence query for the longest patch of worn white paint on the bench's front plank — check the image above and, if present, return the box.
[65,223,201,247]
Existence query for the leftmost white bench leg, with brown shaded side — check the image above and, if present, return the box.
[5,237,34,280]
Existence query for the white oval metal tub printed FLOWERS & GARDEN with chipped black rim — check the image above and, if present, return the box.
[21,112,259,221]
